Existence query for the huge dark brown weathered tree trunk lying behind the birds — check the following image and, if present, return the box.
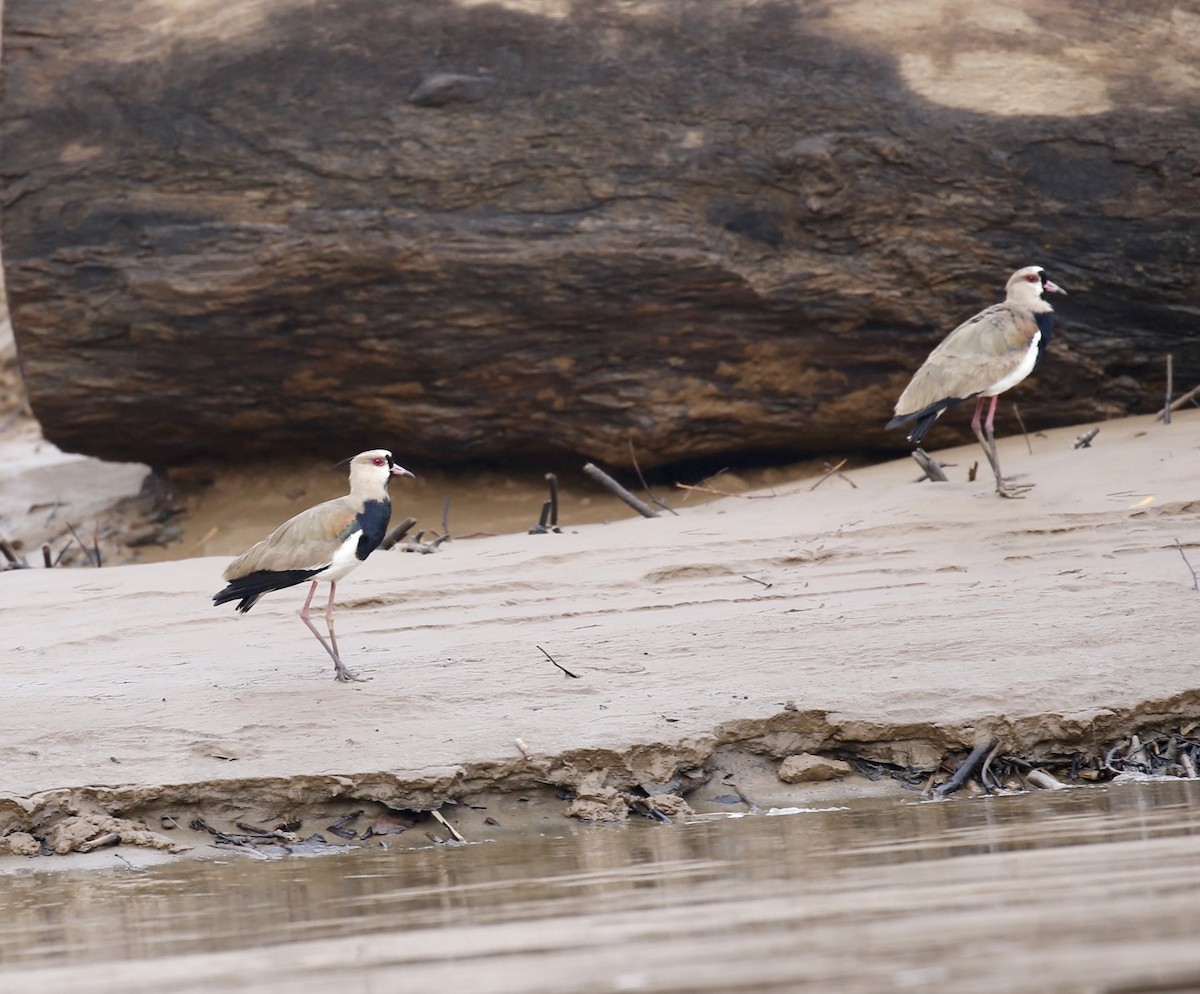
[0,0,1200,466]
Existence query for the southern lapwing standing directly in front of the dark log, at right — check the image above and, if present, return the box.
[887,265,1067,497]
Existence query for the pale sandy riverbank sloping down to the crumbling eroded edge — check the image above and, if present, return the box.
[0,413,1200,859]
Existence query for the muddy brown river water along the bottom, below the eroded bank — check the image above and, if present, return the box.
[0,782,1200,994]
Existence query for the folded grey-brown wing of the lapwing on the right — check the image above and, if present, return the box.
[896,304,1038,417]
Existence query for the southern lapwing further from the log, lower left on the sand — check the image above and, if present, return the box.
[212,449,413,682]
